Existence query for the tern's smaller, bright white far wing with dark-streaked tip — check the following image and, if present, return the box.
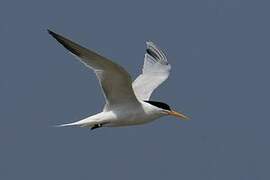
[132,42,171,100]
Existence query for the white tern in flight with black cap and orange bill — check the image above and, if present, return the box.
[48,30,188,129]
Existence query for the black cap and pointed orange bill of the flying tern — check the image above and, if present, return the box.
[144,101,189,120]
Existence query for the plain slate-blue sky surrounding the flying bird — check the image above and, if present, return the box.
[0,0,270,180]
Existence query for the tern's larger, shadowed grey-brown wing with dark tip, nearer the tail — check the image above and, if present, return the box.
[48,30,137,109]
